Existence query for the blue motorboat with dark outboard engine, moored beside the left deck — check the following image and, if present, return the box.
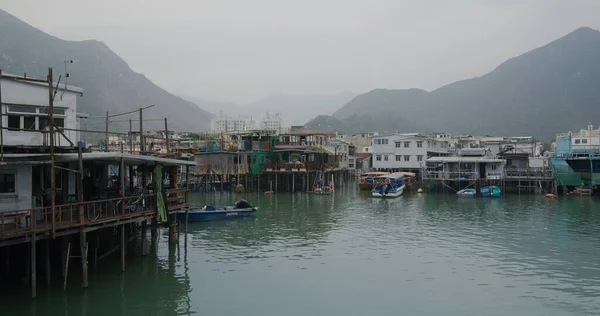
[177,200,258,222]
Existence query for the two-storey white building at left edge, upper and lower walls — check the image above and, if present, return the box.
[0,74,83,212]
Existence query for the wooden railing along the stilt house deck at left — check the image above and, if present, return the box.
[0,193,162,237]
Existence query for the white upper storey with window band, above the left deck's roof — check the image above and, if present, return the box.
[0,74,83,146]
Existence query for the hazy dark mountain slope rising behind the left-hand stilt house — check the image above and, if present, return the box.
[0,10,213,131]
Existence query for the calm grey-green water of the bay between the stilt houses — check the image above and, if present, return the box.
[0,192,600,316]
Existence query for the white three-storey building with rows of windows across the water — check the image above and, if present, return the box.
[373,133,450,171]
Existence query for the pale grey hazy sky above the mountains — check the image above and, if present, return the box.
[0,0,600,102]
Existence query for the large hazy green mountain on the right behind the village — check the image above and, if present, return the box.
[307,28,600,140]
